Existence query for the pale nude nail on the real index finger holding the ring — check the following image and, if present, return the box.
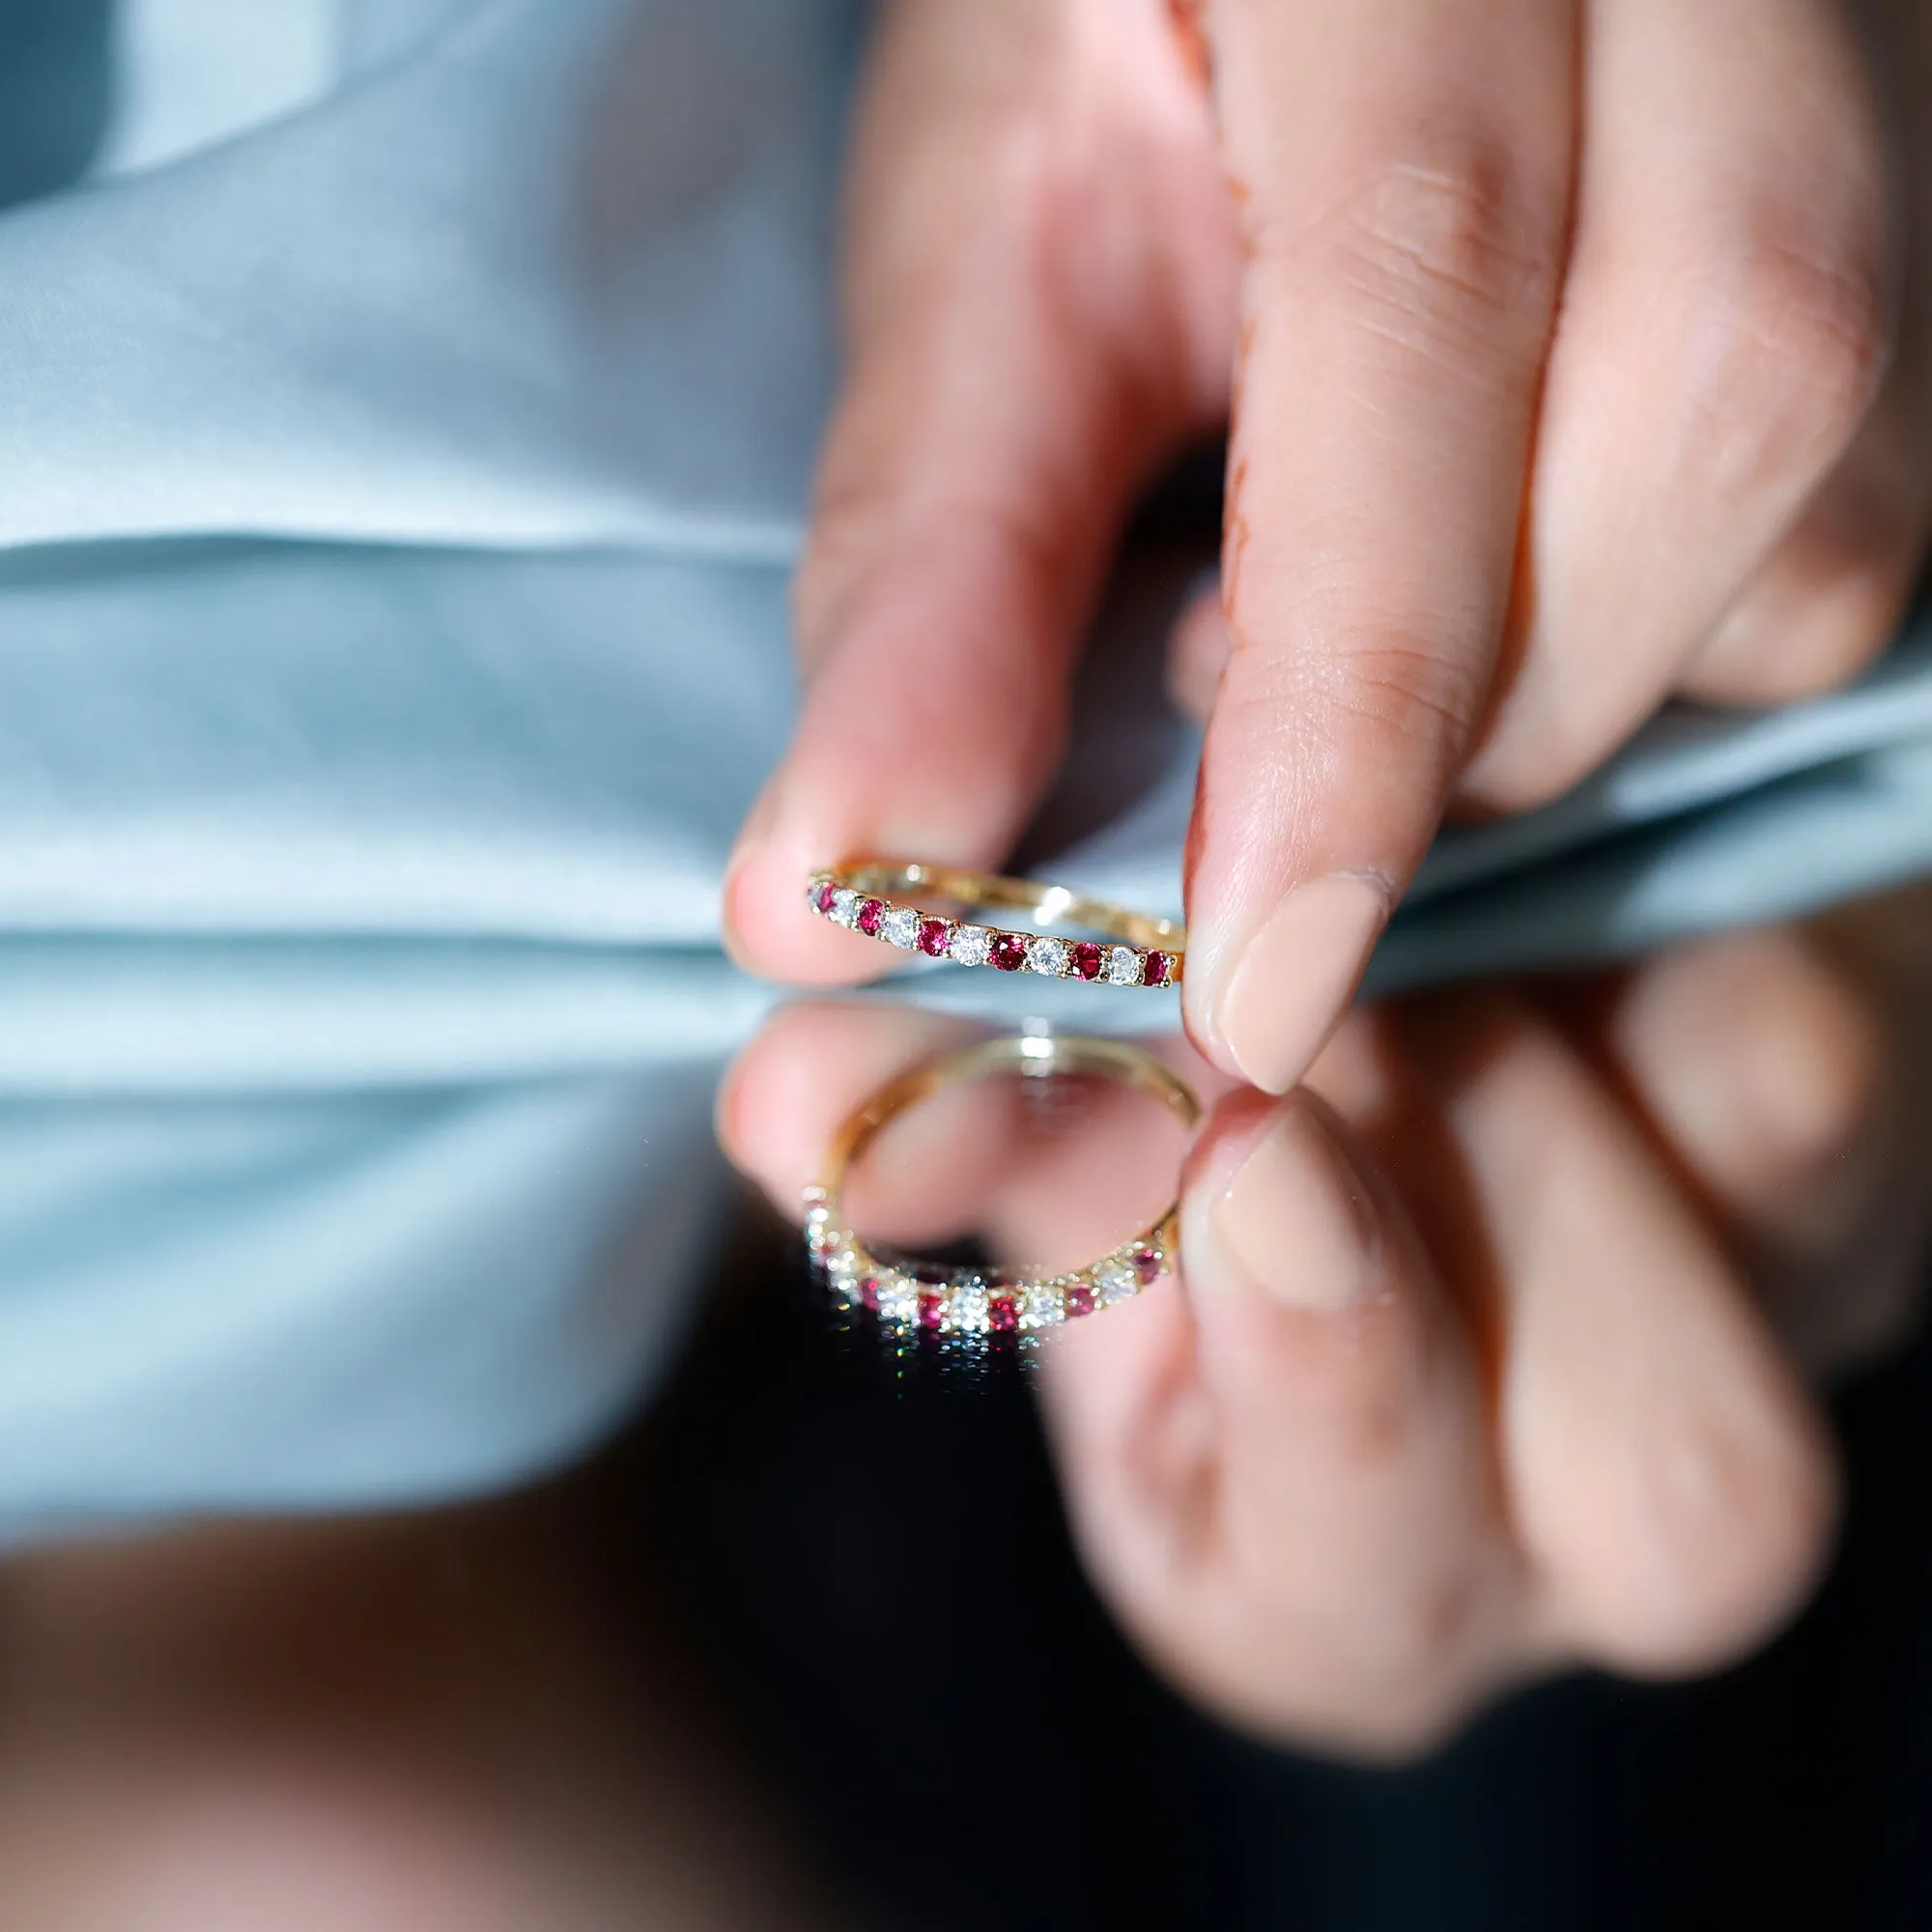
[1211,873,1389,1094]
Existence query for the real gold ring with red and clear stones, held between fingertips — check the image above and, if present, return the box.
[806,860,1188,985]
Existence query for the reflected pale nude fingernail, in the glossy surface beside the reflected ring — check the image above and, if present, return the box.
[1188,1105,1381,1310]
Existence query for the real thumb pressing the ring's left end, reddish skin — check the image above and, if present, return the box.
[724,0,1235,983]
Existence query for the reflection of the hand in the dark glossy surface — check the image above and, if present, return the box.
[719,895,1932,1756]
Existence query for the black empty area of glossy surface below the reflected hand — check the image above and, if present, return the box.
[620,1209,1932,1932]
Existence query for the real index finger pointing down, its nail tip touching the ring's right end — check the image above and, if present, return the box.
[1184,0,1577,1094]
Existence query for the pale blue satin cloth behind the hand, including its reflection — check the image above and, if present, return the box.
[0,0,1932,1540]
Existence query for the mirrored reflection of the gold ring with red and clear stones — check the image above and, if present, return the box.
[806,1034,1202,1335]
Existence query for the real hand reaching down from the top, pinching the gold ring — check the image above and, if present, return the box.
[726,0,1932,1092]
